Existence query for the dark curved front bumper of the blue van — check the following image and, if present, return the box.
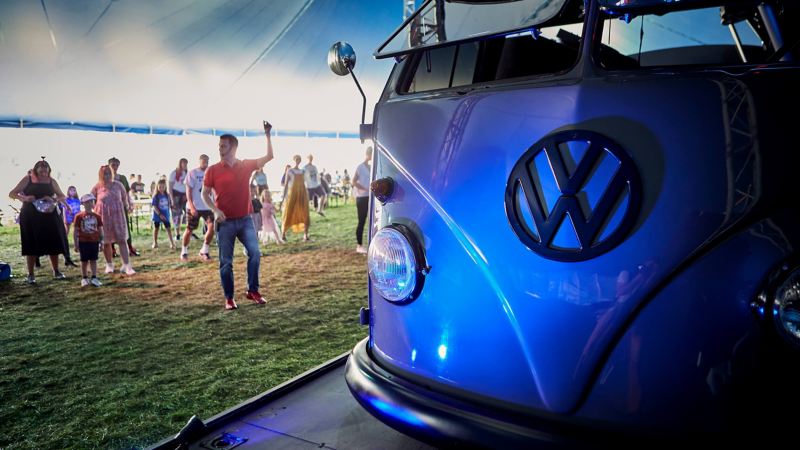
[345,339,636,448]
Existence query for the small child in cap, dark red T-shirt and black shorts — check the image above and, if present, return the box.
[73,194,103,287]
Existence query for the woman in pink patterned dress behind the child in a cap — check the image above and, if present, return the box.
[92,166,136,275]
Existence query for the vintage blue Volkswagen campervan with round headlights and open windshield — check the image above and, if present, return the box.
[332,0,800,448]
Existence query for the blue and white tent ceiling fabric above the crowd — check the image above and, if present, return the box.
[0,0,402,130]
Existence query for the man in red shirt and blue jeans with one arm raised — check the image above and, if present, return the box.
[203,121,272,309]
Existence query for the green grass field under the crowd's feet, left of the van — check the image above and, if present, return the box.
[0,204,367,450]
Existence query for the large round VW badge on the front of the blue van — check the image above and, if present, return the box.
[505,131,642,261]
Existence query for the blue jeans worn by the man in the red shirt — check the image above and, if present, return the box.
[217,216,261,298]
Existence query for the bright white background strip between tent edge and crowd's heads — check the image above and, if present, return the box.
[0,128,368,220]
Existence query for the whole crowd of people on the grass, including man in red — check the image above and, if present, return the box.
[9,121,372,309]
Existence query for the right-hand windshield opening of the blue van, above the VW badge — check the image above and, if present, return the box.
[598,0,797,70]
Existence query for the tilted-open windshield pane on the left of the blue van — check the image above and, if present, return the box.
[375,0,567,59]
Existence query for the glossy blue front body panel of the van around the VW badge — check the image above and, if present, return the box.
[370,71,797,413]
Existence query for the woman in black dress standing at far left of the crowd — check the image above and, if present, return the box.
[8,159,66,284]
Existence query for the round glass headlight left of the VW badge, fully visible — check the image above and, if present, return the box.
[367,224,424,302]
